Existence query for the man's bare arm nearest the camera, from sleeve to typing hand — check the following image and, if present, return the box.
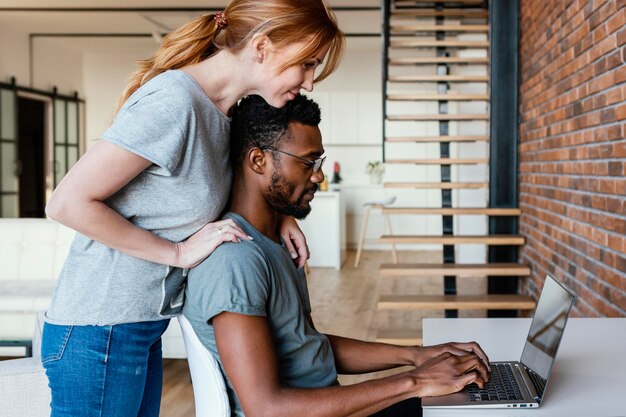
[213,312,483,417]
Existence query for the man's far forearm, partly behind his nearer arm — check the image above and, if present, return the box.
[326,335,418,374]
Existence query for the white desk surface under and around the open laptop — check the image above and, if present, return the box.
[423,318,626,417]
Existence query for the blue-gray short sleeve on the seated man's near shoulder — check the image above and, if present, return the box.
[185,241,270,322]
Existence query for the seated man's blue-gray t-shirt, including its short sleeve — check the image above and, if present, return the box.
[183,213,337,417]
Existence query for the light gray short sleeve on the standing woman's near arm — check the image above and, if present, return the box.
[101,89,192,176]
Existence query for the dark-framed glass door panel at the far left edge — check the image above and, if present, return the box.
[0,87,20,217]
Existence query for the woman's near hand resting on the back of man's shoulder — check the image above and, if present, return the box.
[173,219,252,268]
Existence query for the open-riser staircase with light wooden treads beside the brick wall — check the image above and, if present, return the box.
[377,0,535,344]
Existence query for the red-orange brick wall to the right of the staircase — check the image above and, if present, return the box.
[519,0,626,317]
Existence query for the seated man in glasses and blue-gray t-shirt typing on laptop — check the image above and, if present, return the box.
[183,95,488,417]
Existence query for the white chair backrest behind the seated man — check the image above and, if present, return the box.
[178,315,230,417]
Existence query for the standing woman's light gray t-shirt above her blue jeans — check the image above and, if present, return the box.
[47,70,231,325]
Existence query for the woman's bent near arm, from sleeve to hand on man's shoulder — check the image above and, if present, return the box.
[46,140,247,268]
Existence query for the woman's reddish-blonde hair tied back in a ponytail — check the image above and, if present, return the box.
[116,0,345,112]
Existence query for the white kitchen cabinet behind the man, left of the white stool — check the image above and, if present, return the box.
[299,191,346,270]
